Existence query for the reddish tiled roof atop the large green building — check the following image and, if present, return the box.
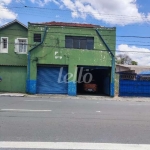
[30,21,101,28]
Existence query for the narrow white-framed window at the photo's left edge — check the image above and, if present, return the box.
[0,37,8,53]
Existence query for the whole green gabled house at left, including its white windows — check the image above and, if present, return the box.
[0,20,28,93]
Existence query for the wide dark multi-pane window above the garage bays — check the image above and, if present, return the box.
[65,36,94,50]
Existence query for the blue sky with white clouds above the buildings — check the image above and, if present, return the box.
[0,0,150,65]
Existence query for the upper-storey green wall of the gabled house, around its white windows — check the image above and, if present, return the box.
[0,23,28,66]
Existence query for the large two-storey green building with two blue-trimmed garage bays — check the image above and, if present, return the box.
[27,22,116,96]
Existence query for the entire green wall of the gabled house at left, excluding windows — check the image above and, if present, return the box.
[0,23,28,93]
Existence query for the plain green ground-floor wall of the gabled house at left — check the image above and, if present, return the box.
[0,66,27,93]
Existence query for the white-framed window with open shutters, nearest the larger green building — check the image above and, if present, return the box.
[15,38,28,54]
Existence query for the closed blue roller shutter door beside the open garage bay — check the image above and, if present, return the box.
[37,67,68,94]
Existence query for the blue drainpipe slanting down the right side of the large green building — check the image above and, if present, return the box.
[95,29,115,96]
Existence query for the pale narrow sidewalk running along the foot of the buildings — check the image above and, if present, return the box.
[0,93,150,102]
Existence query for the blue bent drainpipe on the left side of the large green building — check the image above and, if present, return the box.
[27,27,48,92]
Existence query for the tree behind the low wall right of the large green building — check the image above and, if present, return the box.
[116,54,138,65]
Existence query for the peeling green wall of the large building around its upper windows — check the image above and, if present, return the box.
[28,24,116,80]
